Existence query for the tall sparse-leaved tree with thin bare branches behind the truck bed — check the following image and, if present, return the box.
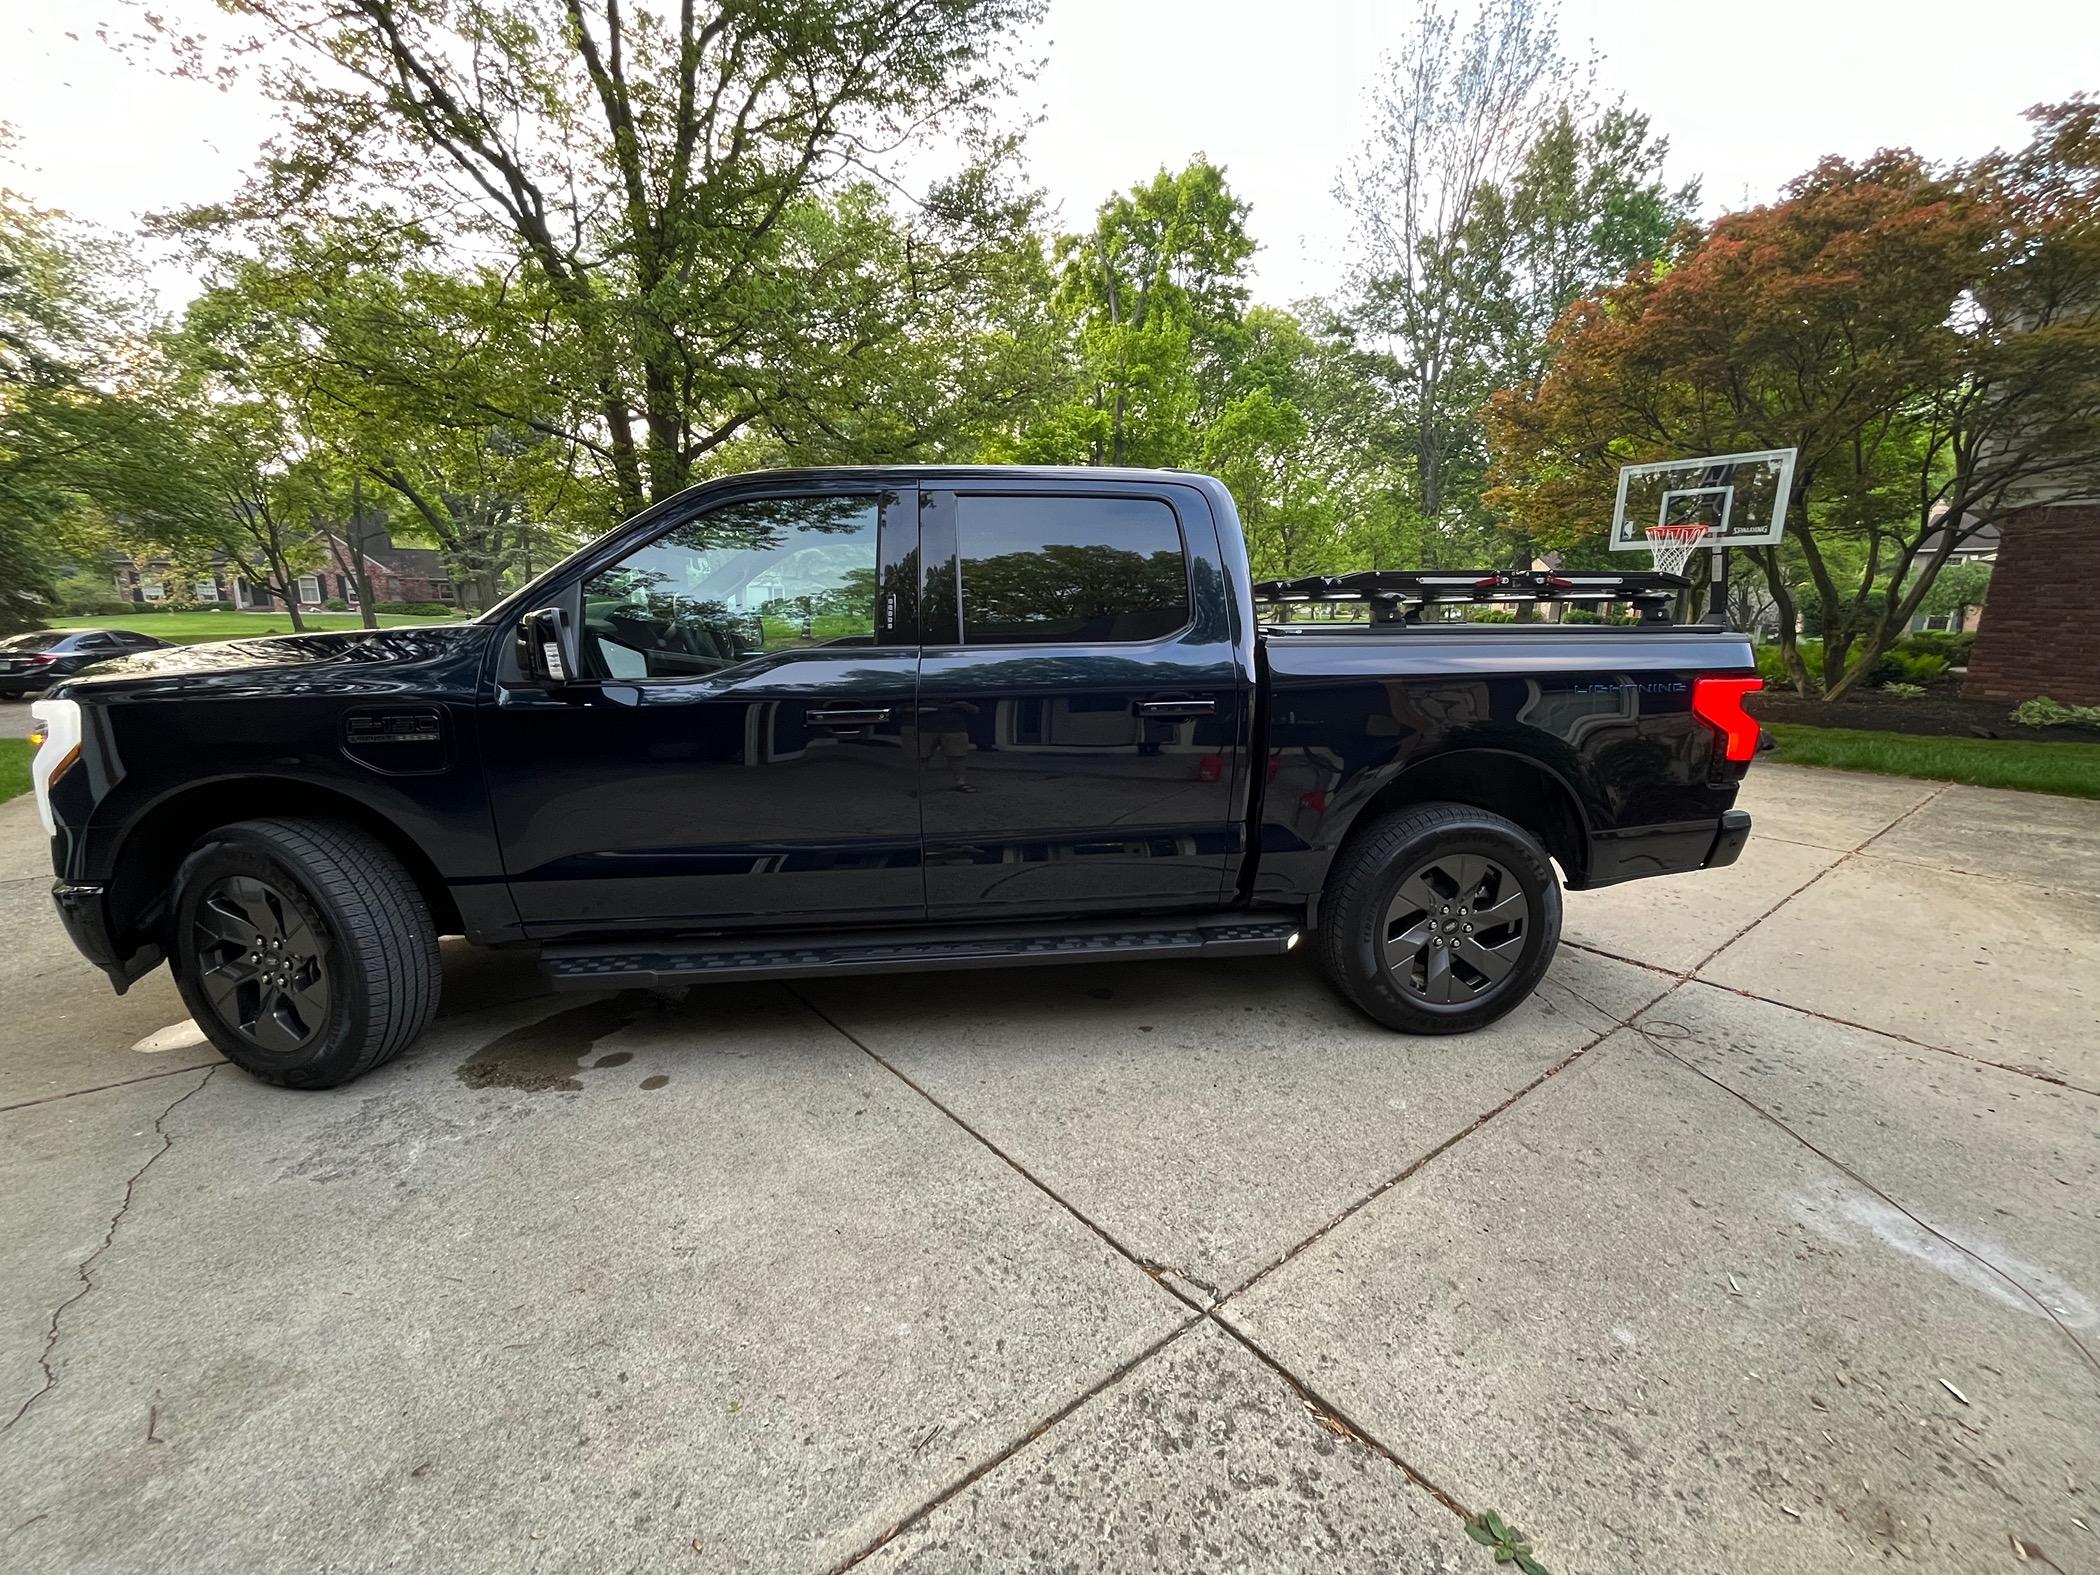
[1338,0,1697,565]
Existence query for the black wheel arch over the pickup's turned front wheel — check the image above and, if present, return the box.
[109,777,464,939]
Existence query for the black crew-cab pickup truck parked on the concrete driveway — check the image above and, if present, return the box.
[34,466,1758,1088]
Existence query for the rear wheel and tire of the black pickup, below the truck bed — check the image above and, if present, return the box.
[1319,804,1560,1033]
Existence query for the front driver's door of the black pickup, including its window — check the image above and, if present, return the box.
[483,481,926,935]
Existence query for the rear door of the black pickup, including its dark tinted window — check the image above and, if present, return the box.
[907,481,1252,918]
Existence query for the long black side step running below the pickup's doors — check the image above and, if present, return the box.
[540,914,1302,989]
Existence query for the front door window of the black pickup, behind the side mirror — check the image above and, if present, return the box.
[584,498,880,678]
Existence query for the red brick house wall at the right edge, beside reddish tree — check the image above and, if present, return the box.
[1961,498,2100,706]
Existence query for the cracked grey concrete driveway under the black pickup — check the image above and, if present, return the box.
[0,764,2100,1575]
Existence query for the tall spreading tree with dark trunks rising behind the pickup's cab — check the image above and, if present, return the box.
[161,0,1040,512]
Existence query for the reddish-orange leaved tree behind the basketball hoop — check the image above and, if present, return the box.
[1491,99,2100,699]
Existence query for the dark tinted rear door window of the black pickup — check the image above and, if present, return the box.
[956,496,1189,645]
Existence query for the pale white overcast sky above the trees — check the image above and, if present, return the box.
[0,0,2100,307]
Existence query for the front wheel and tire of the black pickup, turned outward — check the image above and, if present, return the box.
[168,819,441,1088]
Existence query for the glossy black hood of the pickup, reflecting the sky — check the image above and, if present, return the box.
[63,624,494,699]
